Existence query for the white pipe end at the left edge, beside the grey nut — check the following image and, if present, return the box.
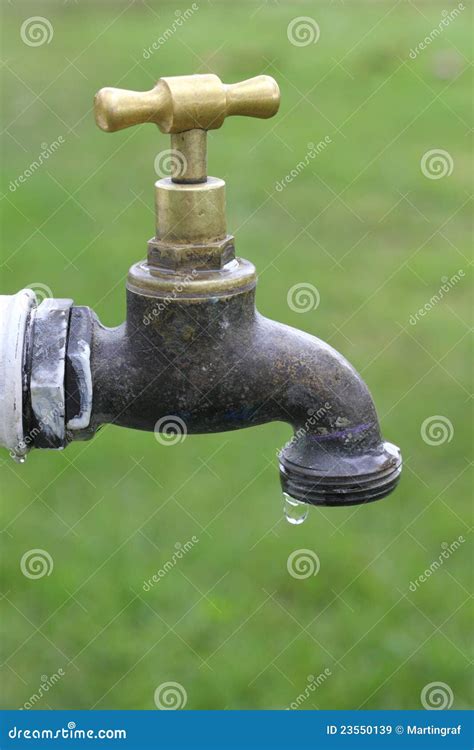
[0,289,37,456]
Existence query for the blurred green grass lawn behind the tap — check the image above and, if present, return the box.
[0,0,472,709]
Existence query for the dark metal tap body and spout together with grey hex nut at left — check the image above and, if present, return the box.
[0,280,401,505]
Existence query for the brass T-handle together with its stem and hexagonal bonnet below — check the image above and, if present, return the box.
[94,73,280,276]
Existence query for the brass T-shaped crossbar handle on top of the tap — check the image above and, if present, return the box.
[94,73,280,133]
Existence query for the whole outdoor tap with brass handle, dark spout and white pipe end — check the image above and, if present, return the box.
[0,74,401,505]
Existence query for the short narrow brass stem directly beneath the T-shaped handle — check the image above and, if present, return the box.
[171,128,207,185]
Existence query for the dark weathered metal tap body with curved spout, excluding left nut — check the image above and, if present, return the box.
[60,264,401,505]
